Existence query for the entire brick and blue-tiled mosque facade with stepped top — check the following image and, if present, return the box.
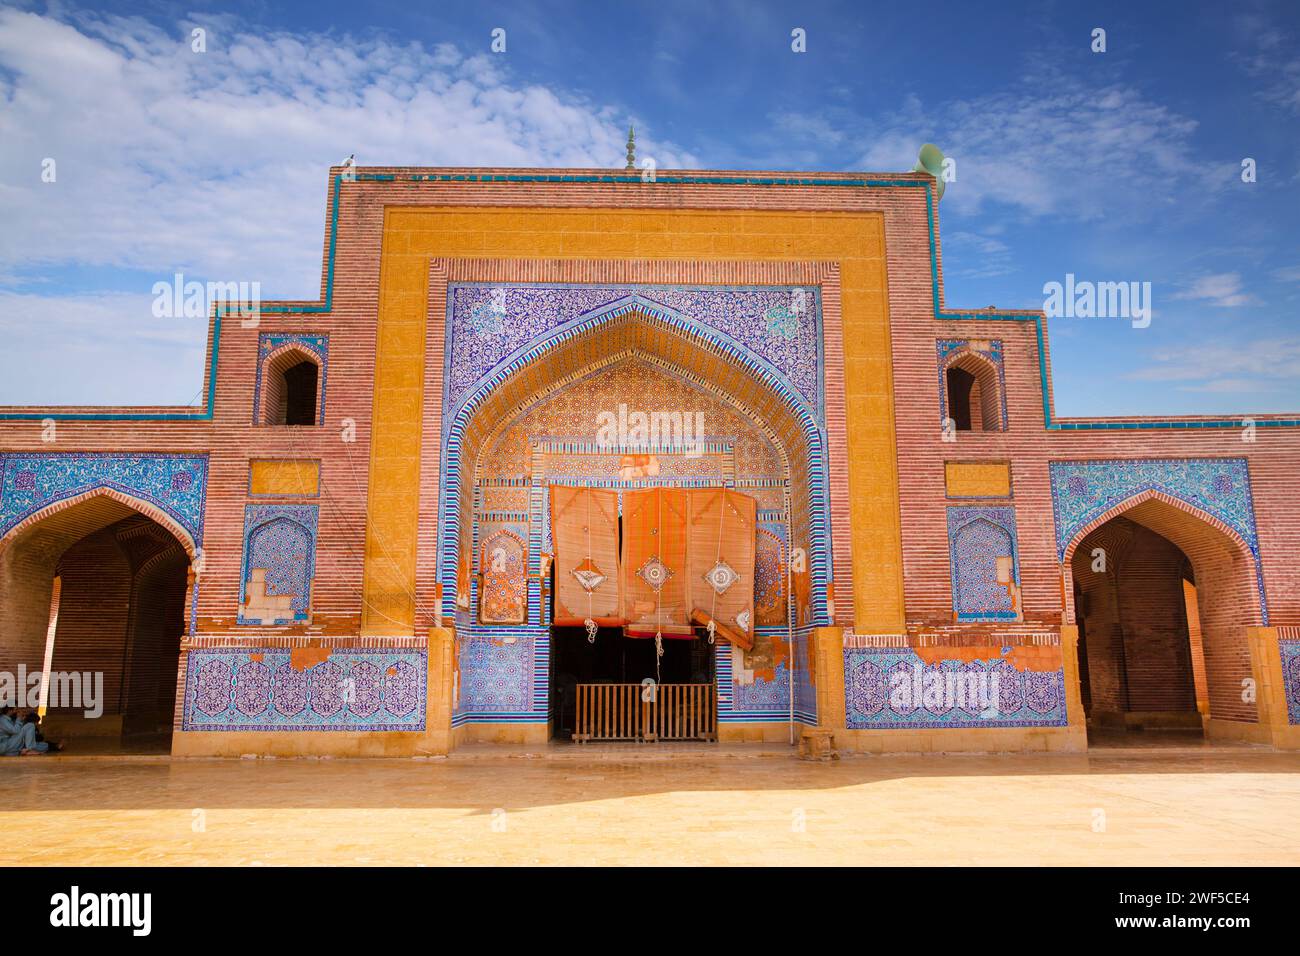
[0,168,1300,756]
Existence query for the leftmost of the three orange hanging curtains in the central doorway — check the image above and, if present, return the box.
[551,485,624,627]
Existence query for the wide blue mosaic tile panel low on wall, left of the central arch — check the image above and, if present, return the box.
[181,648,429,731]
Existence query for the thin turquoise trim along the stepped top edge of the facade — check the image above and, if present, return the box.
[0,167,1300,432]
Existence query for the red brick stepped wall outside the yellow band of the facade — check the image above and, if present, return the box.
[0,169,1300,719]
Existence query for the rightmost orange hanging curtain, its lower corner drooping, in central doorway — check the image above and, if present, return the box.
[688,488,758,650]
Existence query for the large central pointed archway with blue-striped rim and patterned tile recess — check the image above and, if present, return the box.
[438,295,829,738]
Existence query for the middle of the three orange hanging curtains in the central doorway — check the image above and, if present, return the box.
[621,488,694,637]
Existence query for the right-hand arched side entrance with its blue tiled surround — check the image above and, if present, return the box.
[1053,459,1266,736]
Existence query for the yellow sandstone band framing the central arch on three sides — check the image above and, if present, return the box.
[363,207,904,642]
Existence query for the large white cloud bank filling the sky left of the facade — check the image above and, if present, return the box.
[0,9,697,402]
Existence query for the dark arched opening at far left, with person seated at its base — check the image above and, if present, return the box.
[0,486,198,750]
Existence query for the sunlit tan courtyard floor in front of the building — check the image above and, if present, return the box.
[0,747,1300,866]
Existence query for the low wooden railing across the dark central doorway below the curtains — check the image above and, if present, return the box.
[573,684,718,743]
